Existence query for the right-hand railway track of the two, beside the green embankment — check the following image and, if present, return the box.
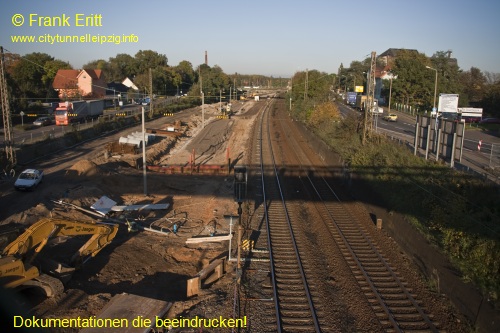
[280,112,439,332]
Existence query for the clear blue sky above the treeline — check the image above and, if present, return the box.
[0,0,500,77]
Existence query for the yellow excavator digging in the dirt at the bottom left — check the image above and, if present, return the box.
[0,218,118,297]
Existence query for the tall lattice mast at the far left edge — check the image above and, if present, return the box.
[0,46,17,168]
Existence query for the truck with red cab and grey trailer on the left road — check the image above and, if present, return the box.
[54,100,104,126]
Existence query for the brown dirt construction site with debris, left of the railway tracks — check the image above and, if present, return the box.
[0,87,264,332]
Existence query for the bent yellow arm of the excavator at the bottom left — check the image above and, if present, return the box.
[0,218,118,294]
